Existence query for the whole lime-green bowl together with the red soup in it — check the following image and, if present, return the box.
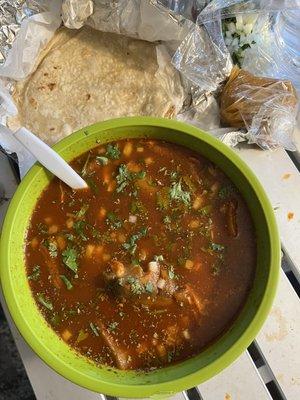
[1,118,280,397]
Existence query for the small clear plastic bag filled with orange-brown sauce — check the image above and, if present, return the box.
[220,67,297,150]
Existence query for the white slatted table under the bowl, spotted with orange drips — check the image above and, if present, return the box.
[0,137,300,400]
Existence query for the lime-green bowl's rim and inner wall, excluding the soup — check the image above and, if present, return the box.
[0,117,280,398]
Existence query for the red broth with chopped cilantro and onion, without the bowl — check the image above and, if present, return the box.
[26,139,256,370]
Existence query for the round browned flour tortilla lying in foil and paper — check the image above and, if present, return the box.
[8,27,183,144]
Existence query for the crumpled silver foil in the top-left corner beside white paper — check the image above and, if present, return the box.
[0,0,45,64]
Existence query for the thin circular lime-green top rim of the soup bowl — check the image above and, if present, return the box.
[0,117,280,397]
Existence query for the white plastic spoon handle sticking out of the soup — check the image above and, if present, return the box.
[11,128,88,189]
